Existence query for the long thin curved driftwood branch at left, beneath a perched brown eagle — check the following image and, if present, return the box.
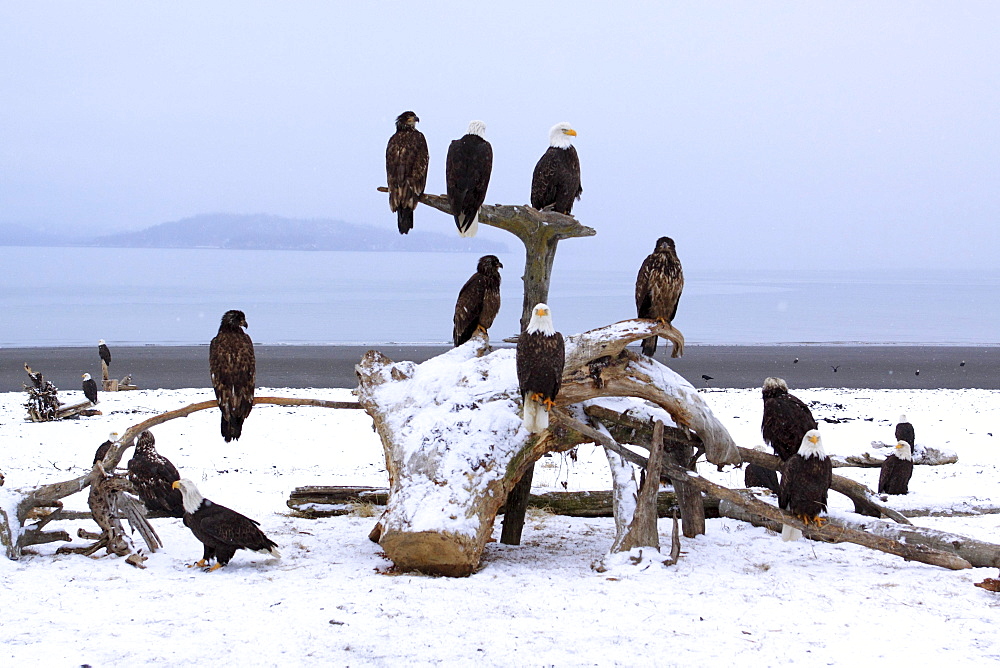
[0,397,361,560]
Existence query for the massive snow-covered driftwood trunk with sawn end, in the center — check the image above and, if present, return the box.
[357,320,740,576]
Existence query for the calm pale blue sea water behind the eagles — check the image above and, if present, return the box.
[0,247,1000,347]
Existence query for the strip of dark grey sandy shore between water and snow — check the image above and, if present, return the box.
[0,345,1000,392]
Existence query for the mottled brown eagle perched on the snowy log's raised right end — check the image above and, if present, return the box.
[635,237,684,357]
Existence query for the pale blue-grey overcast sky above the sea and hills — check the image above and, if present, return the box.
[0,0,1000,273]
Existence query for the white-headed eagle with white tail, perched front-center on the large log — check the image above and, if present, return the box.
[517,304,566,434]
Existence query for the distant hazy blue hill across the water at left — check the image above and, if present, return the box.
[0,213,508,253]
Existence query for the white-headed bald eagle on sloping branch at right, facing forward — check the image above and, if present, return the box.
[778,429,833,540]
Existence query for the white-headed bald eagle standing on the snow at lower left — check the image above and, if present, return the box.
[172,478,281,572]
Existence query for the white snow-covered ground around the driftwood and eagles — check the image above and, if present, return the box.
[0,388,1000,666]
